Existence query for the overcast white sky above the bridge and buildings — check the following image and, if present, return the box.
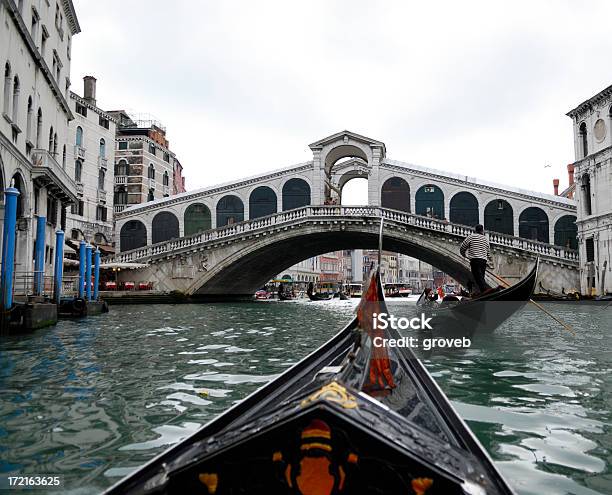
[71,0,612,200]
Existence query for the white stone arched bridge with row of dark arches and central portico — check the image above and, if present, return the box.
[114,131,578,295]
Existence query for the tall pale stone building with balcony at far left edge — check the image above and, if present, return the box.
[0,0,80,277]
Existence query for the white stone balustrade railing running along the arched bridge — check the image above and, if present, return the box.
[112,205,578,263]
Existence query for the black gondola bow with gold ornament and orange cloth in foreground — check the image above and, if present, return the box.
[107,269,513,495]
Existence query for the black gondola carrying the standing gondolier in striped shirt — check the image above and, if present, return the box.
[417,258,540,334]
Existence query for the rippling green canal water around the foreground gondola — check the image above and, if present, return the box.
[0,301,612,495]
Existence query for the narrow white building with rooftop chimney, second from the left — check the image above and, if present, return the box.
[66,76,116,251]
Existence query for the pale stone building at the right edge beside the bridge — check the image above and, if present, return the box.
[567,86,612,294]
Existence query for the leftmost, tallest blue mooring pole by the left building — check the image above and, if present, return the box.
[0,187,19,316]
